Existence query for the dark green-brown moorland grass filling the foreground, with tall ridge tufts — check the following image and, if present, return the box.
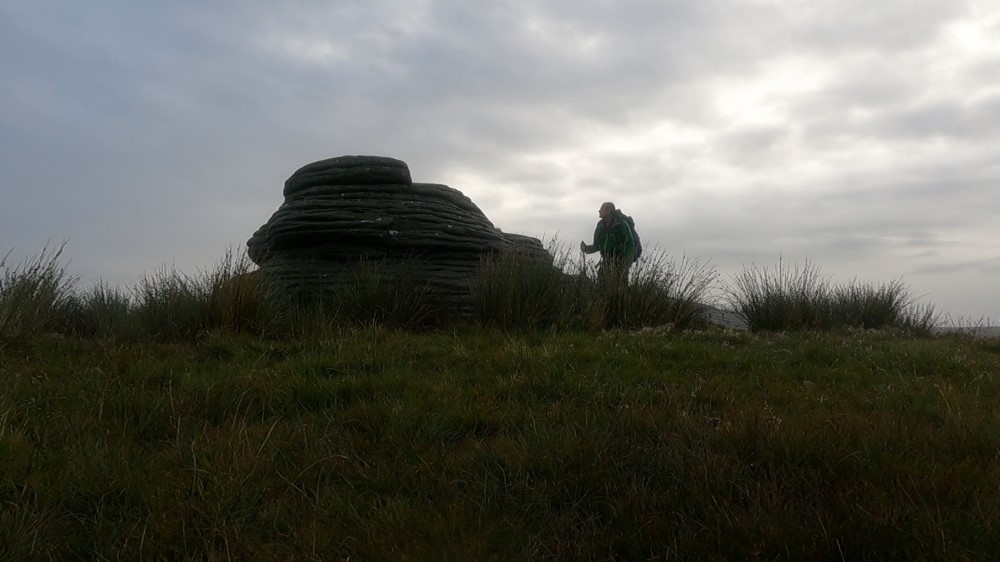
[0,244,1000,560]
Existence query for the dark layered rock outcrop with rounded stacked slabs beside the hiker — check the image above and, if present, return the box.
[247,156,552,313]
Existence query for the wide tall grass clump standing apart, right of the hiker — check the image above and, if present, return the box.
[727,260,937,334]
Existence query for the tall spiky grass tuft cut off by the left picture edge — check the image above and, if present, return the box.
[0,243,75,348]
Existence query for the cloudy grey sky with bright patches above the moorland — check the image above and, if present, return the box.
[0,0,1000,324]
